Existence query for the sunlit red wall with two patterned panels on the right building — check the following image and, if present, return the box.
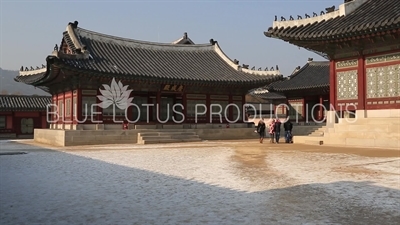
[331,50,400,111]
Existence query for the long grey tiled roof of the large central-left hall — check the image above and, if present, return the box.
[17,22,283,86]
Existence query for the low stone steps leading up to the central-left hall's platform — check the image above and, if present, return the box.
[137,131,201,144]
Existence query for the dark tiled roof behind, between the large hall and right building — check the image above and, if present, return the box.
[268,61,329,92]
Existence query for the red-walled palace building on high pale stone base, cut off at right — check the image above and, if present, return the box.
[264,0,400,148]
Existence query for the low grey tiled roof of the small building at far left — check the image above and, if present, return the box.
[0,95,51,111]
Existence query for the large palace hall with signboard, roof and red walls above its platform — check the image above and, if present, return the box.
[15,21,283,130]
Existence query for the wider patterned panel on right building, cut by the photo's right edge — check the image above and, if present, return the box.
[367,64,400,98]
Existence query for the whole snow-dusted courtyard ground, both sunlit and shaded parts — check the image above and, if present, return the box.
[0,140,400,225]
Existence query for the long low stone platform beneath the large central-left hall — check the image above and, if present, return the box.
[34,124,321,147]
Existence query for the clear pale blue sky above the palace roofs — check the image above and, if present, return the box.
[0,0,343,76]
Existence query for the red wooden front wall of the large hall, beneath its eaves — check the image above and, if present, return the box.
[51,89,244,125]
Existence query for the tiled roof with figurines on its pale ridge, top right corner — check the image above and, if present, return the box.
[264,0,400,40]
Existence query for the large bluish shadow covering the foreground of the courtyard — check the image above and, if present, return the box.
[0,140,400,225]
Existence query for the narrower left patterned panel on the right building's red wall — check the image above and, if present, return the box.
[337,70,358,100]
